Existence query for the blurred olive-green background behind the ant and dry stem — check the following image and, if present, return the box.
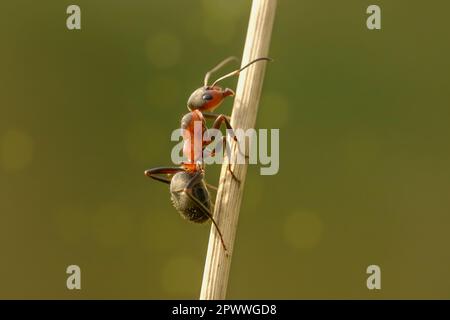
[0,0,450,299]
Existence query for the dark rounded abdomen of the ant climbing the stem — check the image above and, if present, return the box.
[170,171,212,223]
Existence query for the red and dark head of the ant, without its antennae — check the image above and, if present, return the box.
[187,86,234,111]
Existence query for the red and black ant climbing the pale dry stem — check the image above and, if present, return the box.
[145,57,271,251]
